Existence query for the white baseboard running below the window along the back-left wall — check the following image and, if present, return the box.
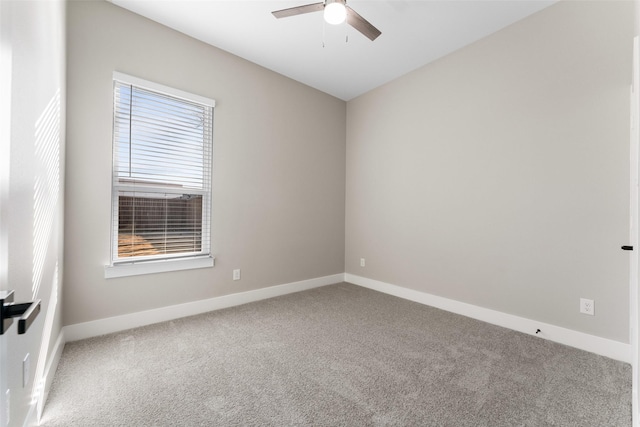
[63,273,344,342]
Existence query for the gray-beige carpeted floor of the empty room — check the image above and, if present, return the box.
[42,283,631,427]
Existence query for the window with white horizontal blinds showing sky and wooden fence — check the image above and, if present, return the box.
[107,73,214,277]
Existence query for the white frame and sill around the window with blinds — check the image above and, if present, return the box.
[105,72,215,278]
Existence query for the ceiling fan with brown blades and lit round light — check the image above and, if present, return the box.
[271,0,382,41]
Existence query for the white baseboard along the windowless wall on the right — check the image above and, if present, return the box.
[344,273,632,363]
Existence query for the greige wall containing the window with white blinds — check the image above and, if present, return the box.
[63,2,346,325]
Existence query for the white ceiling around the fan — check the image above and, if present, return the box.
[109,0,555,101]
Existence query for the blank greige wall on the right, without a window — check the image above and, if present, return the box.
[346,2,634,343]
